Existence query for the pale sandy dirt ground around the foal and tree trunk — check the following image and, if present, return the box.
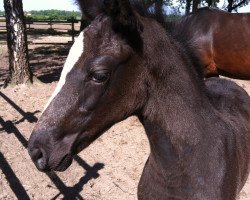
[0,33,250,200]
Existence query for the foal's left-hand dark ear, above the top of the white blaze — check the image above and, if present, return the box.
[76,0,104,20]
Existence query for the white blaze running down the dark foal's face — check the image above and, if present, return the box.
[43,31,84,111]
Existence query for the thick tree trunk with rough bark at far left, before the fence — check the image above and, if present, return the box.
[4,0,32,86]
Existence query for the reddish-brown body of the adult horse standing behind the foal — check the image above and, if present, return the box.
[171,8,250,79]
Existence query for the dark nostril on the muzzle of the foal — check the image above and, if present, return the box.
[30,149,47,171]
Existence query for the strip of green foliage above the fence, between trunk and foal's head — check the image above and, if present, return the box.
[26,10,81,21]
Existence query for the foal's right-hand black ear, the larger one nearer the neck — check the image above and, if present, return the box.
[104,0,143,52]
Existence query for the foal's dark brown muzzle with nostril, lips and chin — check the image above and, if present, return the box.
[28,129,77,172]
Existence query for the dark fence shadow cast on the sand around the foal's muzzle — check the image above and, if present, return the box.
[0,92,104,199]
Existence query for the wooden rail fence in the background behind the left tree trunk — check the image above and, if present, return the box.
[0,16,80,42]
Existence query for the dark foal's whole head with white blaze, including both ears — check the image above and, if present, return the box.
[29,0,160,171]
